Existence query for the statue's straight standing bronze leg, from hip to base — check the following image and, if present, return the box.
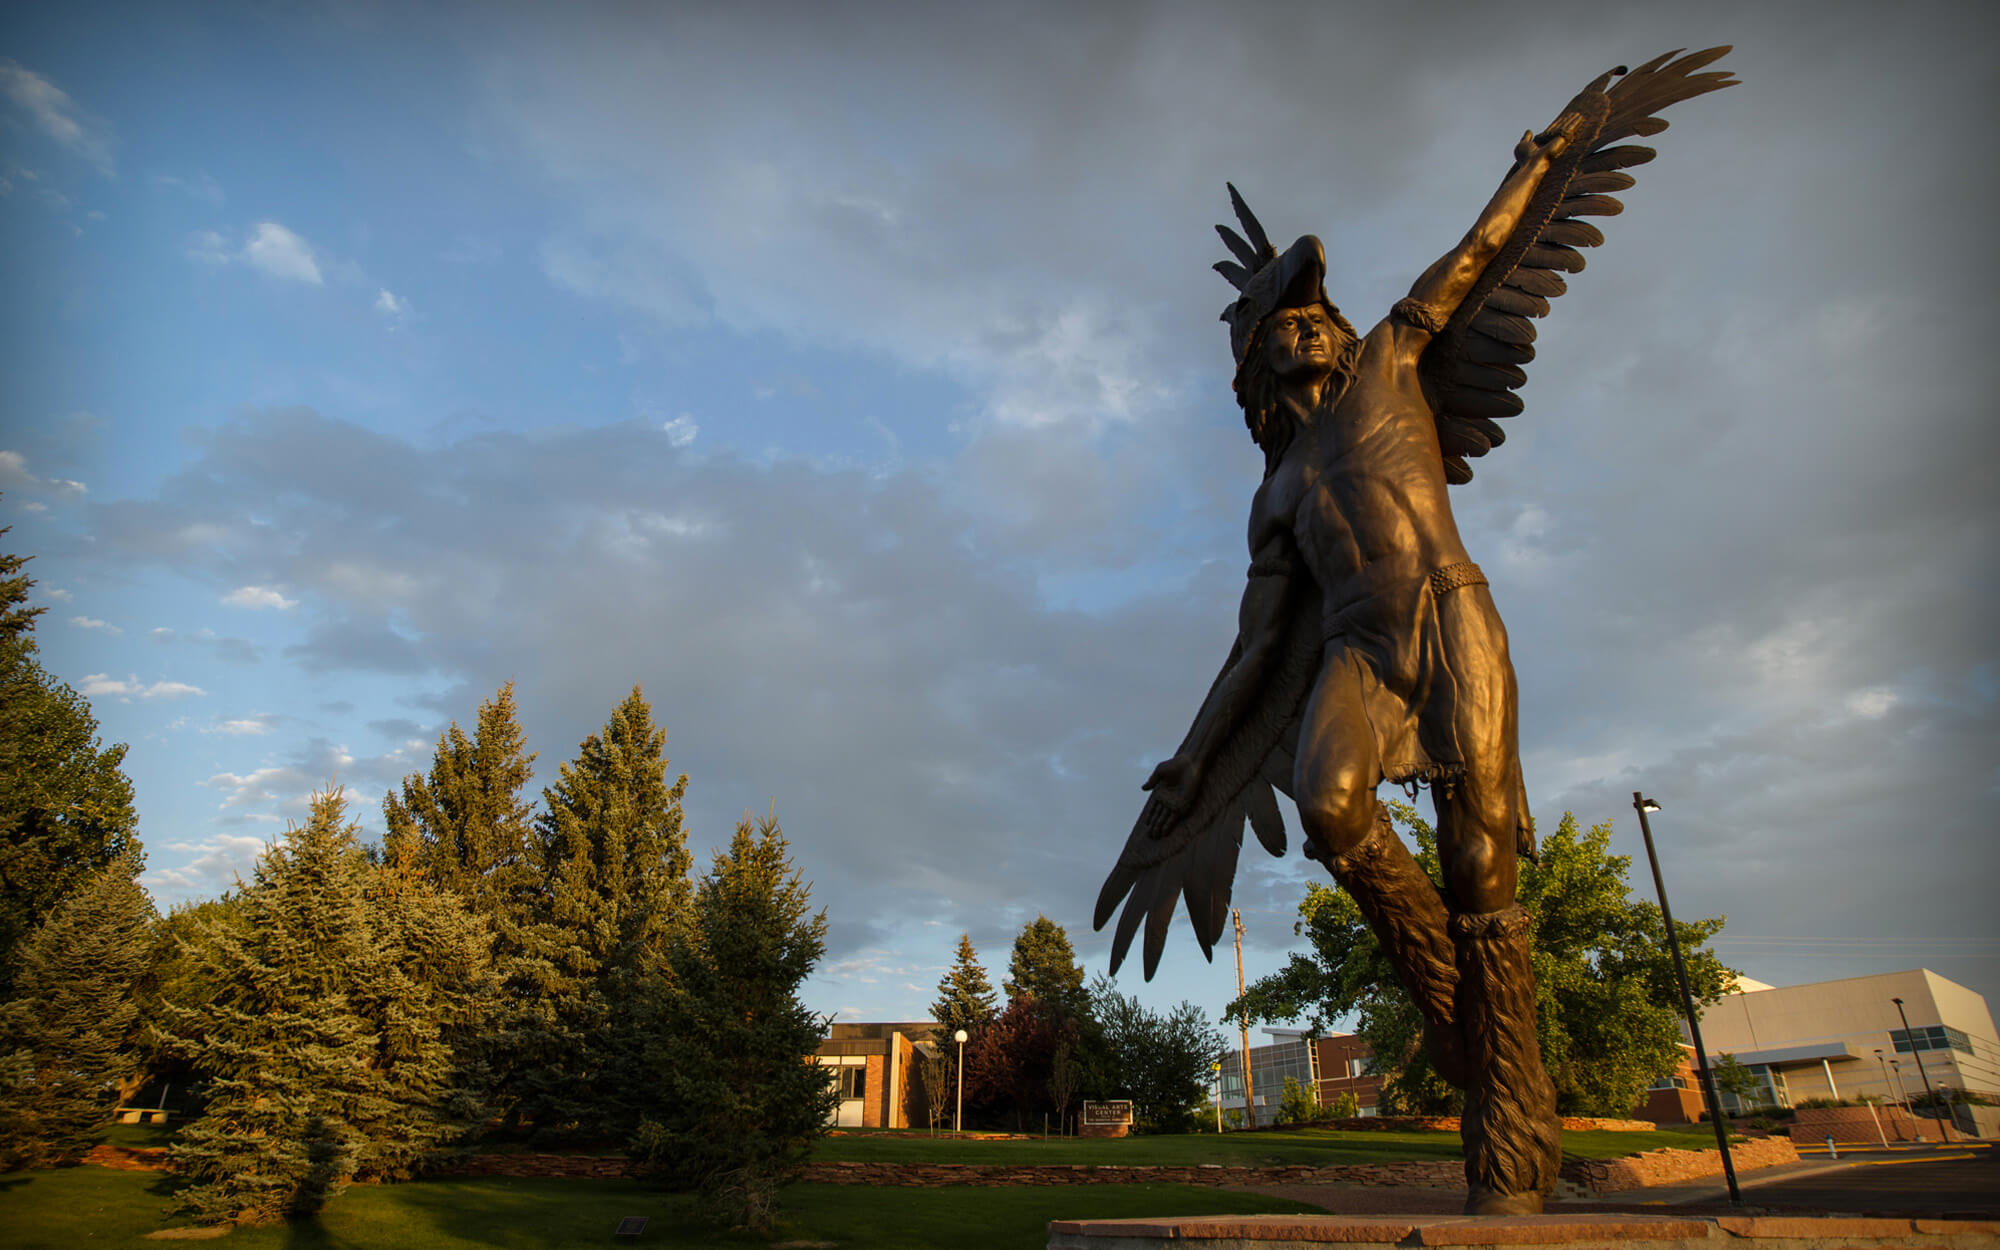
[1438,586,1562,1214]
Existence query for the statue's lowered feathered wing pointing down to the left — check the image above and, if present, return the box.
[1092,594,1320,980]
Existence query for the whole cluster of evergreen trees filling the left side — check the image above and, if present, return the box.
[0,530,834,1226]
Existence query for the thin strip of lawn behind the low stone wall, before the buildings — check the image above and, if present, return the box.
[812,1124,1716,1168]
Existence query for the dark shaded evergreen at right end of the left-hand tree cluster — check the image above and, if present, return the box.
[632,818,836,1232]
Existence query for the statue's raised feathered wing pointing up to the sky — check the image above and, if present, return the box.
[1422,46,1736,484]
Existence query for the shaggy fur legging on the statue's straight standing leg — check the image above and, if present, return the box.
[1452,906,1562,1214]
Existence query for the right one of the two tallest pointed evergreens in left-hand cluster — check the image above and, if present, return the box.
[516,686,690,1140]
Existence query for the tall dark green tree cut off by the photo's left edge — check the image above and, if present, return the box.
[0,530,138,1000]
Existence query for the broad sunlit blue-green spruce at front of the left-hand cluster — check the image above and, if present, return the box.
[162,790,490,1224]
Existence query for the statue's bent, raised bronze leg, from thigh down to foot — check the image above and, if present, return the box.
[1292,648,1466,1086]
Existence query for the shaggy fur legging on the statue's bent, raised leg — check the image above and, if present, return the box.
[1306,804,1466,1086]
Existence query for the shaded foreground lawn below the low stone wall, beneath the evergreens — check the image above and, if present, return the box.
[0,1168,1318,1250]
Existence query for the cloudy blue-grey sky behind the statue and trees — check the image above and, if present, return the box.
[0,2,2000,1020]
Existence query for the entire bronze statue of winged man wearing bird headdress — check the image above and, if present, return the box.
[1096,48,1734,1214]
